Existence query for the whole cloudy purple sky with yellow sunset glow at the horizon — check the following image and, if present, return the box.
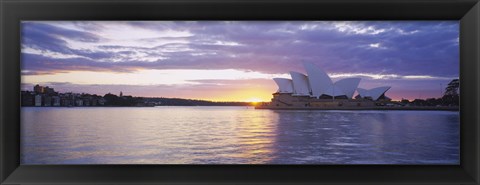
[21,21,460,101]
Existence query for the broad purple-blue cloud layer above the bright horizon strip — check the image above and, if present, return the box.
[21,21,460,100]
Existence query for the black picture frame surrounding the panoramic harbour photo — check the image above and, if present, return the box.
[0,0,480,184]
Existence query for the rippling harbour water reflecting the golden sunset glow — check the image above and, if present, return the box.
[21,107,459,164]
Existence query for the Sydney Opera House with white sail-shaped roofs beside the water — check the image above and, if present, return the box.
[257,63,390,109]
